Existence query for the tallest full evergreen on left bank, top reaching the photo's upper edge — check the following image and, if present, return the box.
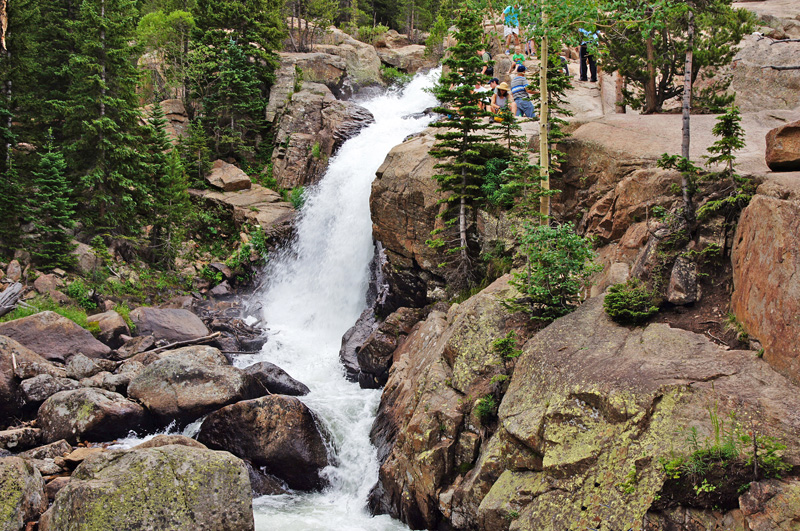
[64,0,150,234]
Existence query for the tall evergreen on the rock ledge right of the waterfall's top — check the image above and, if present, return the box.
[428,8,491,284]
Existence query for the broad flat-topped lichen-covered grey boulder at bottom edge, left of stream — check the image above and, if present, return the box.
[39,445,254,531]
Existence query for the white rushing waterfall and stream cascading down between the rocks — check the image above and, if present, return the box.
[236,72,438,531]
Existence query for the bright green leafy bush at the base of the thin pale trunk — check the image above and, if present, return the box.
[508,222,602,320]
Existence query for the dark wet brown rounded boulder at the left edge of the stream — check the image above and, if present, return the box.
[197,395,328,490]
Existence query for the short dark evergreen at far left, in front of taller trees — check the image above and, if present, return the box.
[27,144,75,269]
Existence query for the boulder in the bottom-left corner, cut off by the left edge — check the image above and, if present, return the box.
[0,457,47,531]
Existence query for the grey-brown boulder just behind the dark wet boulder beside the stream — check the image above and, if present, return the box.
[128,347,255,424]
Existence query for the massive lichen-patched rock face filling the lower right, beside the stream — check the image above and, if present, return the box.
[372,279,800,531]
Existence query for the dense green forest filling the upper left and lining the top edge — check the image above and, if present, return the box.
[0,0,748,280]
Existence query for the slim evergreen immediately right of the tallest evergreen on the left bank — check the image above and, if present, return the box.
[141,104,189,268]
